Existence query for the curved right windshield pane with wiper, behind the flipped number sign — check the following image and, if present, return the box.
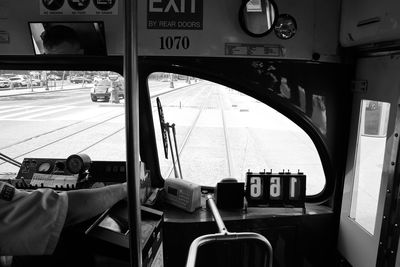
[148,73,325,195]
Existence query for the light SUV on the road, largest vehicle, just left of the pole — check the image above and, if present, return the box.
[90,79,125,102]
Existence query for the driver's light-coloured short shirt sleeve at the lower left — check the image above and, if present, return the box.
[0,182,68,255]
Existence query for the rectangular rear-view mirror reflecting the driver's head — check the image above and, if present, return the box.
[29,22,107,56]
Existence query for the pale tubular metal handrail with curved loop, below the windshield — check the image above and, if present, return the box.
[186,195,273,267]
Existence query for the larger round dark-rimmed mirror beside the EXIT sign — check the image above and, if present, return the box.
[239,0,278,37]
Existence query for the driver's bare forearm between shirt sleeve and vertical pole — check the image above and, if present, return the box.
[65,183,127,226]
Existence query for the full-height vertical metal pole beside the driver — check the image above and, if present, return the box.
[124,0,142,267]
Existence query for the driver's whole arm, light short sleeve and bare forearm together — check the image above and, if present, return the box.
[0,182,126,255]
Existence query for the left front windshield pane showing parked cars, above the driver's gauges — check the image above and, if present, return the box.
[0,70,126,174]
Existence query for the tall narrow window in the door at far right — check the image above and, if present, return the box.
[350,100,390,234]
